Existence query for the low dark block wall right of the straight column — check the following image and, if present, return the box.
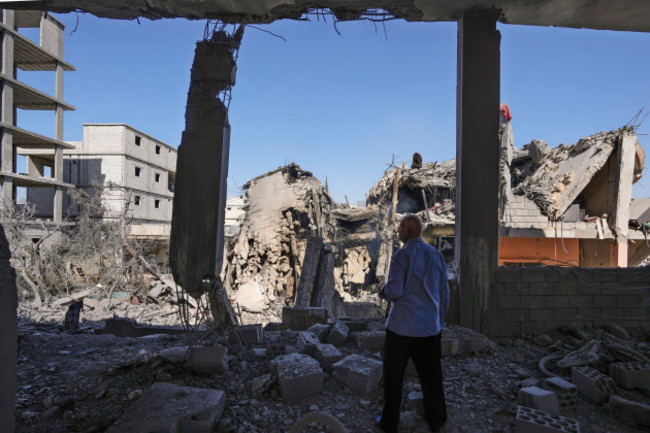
[488,267,650,335]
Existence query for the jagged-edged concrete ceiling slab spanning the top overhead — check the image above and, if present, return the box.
[2,0,650,32]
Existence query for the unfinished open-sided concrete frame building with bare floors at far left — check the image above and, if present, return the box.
[0,9,75,223]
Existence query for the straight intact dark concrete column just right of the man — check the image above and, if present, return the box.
[456,11,501,331]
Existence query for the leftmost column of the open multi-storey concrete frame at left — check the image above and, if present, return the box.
[0,9,15,203]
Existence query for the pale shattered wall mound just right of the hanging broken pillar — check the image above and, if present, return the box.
[224,164,332,323]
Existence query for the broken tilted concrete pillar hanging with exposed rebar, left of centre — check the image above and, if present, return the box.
[169,27,243,298]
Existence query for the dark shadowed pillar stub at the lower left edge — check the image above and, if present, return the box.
[0,226,18,433]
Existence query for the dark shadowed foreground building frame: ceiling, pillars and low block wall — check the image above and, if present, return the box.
[0,0,650,425]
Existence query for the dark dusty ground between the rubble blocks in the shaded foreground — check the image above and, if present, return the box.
[16,306,650,433]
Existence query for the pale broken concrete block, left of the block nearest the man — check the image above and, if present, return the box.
[271,353,324,399]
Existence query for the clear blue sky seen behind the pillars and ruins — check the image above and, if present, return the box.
[12,14,650,202]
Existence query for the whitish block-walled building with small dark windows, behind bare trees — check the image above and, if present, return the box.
[52,123,177,238]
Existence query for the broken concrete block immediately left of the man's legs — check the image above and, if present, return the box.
[332,354,383,394]
